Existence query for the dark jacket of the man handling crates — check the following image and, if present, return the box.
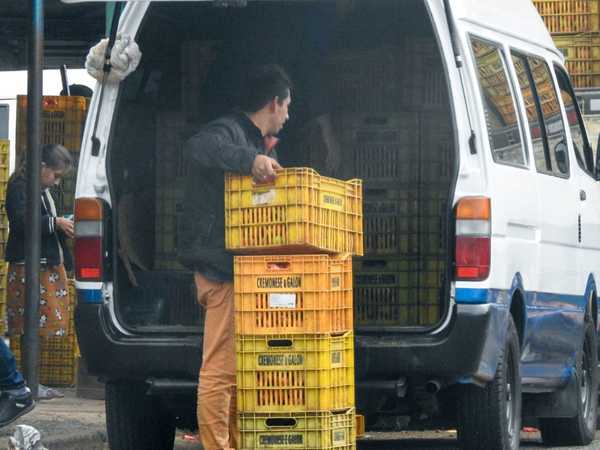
[177,113,275,281]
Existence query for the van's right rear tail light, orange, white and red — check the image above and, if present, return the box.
[455,197,492,281]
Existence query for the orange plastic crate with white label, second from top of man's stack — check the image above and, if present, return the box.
[233,255,353,335]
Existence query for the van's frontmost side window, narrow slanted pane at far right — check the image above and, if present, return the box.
[554,66,594,175]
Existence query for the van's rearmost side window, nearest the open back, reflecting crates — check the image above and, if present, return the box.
[471,38,527,166]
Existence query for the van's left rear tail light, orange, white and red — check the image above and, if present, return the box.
[75,198,104,281]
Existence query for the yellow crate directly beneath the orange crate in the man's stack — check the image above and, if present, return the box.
[236,332,354,413]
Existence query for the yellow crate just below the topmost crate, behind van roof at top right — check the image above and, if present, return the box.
[553,33,600,88]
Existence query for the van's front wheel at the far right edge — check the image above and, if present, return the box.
[540,319,598,446]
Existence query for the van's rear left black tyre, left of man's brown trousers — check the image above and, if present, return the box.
[106,382,175,450]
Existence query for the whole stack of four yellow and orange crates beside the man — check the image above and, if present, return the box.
[225,168,363,450]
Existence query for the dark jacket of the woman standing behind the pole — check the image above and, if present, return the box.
[4,177,73,270]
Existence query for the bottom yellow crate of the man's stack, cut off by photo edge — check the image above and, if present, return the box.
[239,409,356,450]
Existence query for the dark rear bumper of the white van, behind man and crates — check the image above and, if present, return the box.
[75,304,508,390]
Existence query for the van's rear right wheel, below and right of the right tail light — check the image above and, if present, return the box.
[458,316,521,450]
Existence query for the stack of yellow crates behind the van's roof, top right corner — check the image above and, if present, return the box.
[533,0,600,88]
